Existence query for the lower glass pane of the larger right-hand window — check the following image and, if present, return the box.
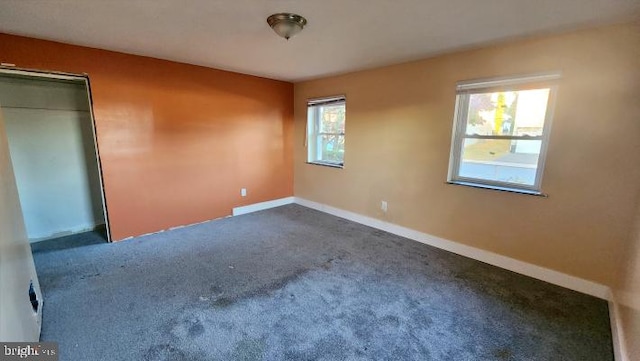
[458,139,542,186]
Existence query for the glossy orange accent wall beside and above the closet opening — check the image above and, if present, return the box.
[0,34,293,240]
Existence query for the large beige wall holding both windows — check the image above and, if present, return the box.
[294,24,640,285]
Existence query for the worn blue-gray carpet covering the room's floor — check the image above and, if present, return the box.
[34,205,613,361]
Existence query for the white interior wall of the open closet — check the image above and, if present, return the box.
[0,77,104,241]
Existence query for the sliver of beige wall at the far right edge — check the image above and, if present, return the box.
[615,200,640,360]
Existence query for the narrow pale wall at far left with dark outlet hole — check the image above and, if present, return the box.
[0,108,42,342]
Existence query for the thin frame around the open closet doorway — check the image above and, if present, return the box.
[0,65,112,242]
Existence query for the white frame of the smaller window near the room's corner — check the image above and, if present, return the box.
[305,95,347,168]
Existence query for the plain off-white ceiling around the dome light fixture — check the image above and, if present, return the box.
[0,0,640,81]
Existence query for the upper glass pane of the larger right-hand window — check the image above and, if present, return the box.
[466,88,550,136]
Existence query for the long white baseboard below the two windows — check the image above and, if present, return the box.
[295,197,611,300]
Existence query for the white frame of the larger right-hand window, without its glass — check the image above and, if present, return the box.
[447,72,561,196]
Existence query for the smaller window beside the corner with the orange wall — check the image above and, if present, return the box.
[307,96,346,168]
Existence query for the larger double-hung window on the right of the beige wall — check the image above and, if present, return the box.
[449,74,560,195]
